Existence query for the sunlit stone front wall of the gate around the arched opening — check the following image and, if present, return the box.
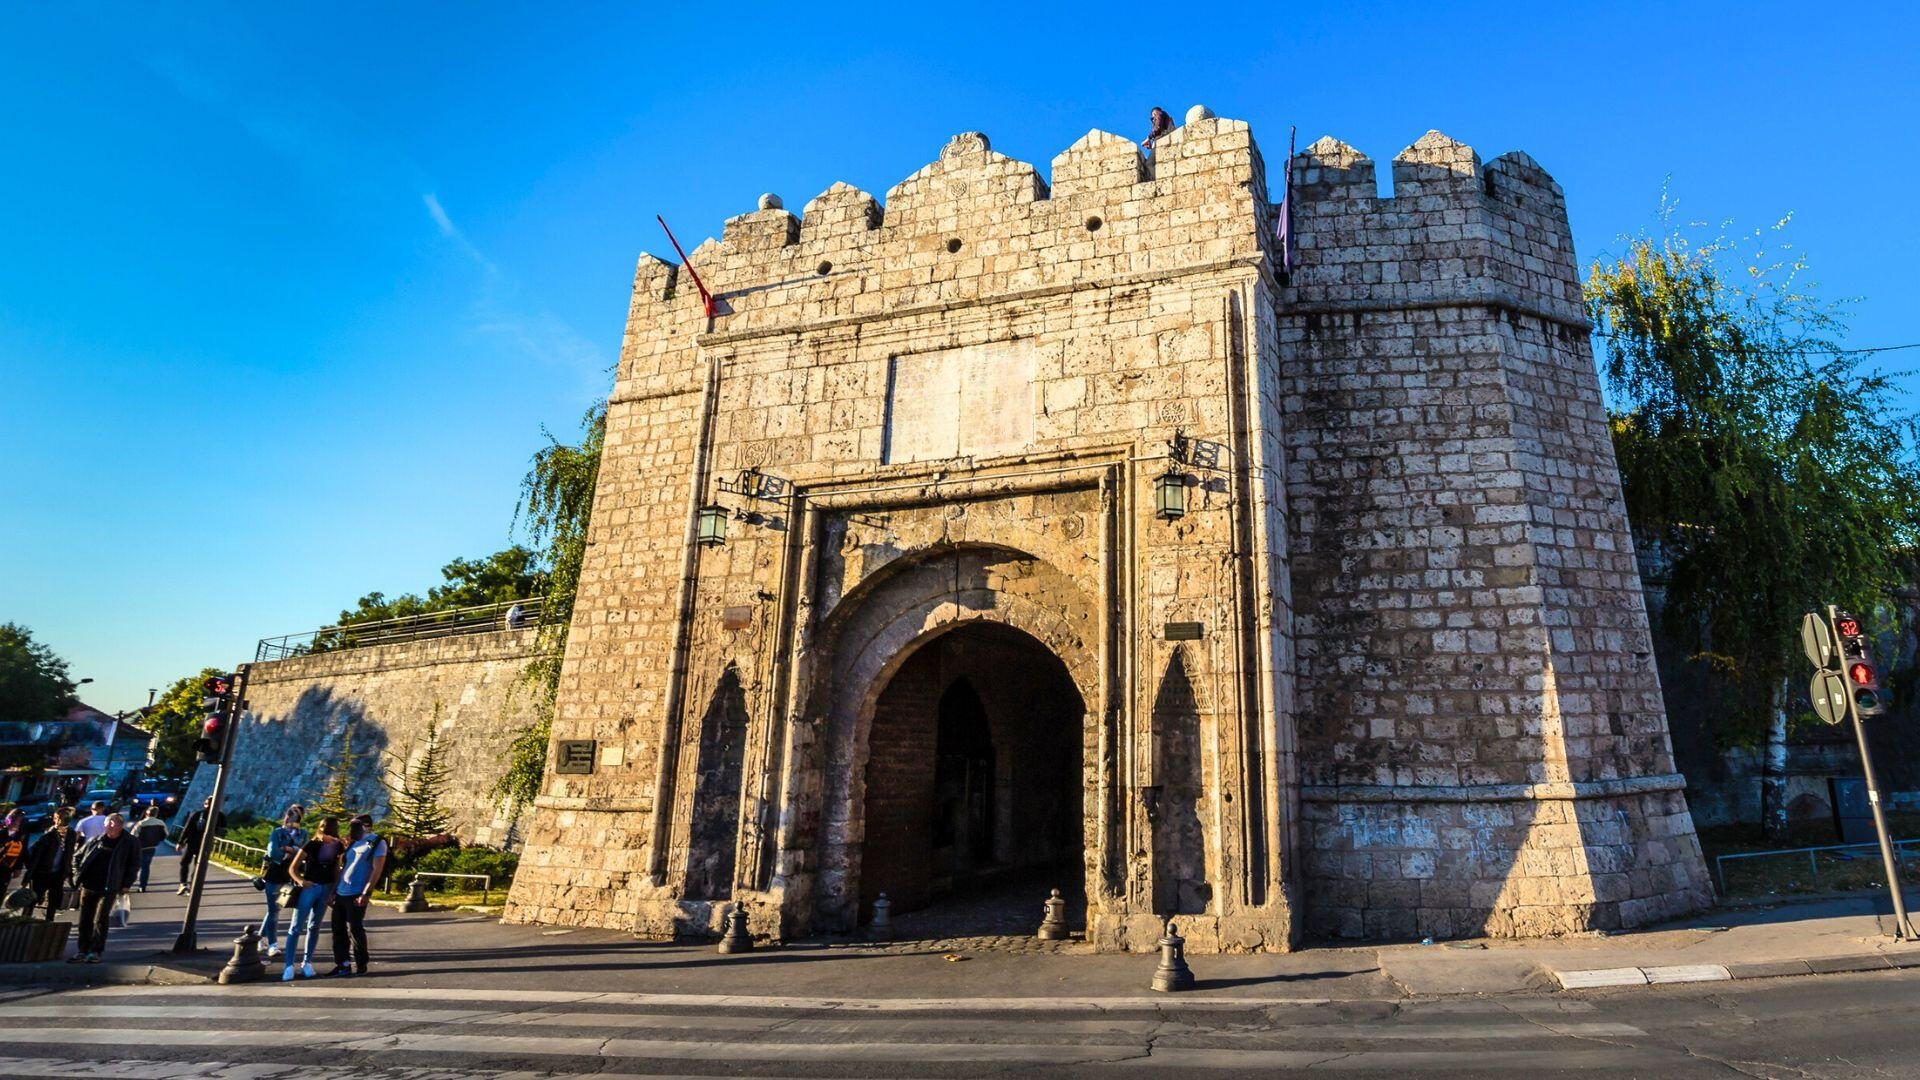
[507,115,1292,947]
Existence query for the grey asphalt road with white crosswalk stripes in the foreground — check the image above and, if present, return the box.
[0,970,1920,1080]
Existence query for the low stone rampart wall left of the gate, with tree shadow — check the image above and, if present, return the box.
[180,630,534,847]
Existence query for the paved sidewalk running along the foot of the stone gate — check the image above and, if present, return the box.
[0,857,1920,1005]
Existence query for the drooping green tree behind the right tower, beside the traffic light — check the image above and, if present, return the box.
[1586,212,1920,838]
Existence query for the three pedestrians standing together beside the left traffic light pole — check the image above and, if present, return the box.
[253,803,388,982]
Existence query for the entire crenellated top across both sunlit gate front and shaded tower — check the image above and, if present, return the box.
[632,106,1582,359]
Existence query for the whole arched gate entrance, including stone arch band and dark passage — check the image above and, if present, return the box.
[808,544,1116,932]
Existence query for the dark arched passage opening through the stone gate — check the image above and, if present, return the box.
[858,621,1087,932]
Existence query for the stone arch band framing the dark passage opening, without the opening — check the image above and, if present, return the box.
[814,546,1102,930]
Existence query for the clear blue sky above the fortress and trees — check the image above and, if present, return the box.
[0,2,1920,709]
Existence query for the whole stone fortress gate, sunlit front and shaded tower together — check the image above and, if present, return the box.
[507,106,1709,951]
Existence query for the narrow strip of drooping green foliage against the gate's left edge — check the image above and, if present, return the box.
[493,404,607,817]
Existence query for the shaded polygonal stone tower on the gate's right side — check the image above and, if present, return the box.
[1279,133,1711,938]
